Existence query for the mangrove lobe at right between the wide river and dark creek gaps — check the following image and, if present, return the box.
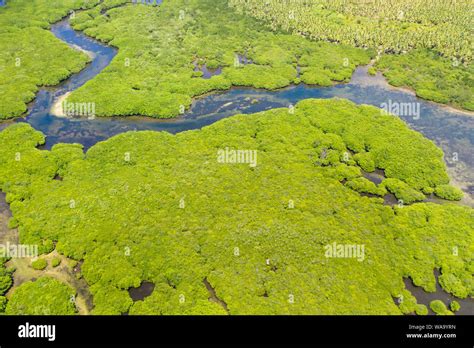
[298,101,449,193]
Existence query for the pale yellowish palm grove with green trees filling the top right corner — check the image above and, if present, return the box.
[228,0,474,110]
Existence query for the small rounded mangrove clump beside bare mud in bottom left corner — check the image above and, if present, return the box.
[5,277,76,315]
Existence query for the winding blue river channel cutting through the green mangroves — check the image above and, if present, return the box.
[0,6,474,314]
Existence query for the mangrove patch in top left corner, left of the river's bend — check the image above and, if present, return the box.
[0,0,98,120]
